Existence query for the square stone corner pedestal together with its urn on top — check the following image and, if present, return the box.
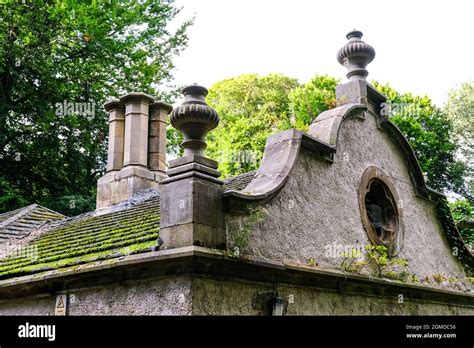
[160,85,226,249]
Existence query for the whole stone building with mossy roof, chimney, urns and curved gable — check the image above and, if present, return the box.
[0,31,474,315]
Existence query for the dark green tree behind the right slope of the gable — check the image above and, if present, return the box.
[374,82,466,191]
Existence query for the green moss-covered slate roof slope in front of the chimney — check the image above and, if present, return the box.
[0,197,160,279]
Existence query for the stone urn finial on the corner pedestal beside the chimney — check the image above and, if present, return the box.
[170,84,219,156]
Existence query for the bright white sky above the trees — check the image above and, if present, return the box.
[172,0,474,106]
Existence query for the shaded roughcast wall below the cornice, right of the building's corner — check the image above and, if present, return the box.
[193,278,474,315]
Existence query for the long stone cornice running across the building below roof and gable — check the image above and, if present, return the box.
[0,246,474,308]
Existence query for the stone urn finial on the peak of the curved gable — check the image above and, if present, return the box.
[337,29,375,81]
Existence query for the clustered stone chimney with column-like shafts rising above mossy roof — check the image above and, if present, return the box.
[97,93,172,209]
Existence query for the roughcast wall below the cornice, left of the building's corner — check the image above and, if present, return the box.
[0,277,192,315]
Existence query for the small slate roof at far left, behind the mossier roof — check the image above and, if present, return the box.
[0,204,65,244]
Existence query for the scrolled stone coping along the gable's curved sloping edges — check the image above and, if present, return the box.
[224,103,443,201]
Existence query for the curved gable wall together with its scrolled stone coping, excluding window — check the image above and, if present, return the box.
[225,106,470,278]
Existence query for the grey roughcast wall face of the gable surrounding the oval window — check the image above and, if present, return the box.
[227,113,464,279]
